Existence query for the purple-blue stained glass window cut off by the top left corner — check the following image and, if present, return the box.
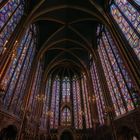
[0,0,24,55]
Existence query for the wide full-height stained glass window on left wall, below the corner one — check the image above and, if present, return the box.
[1,25,37,116]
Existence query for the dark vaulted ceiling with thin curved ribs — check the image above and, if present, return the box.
[30,0,107,75]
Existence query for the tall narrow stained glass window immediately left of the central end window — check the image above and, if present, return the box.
[50,76,60,129]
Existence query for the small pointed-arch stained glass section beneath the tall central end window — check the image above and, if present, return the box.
[61,107,71,126]
